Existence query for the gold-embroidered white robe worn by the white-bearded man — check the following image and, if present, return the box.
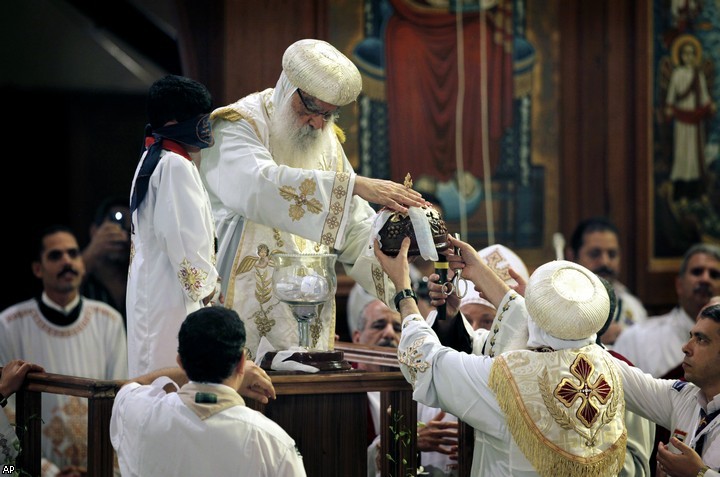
[200,74,395,358]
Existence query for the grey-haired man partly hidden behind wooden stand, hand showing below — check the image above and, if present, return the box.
[347,283,458,477]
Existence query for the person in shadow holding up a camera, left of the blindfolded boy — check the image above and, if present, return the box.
[80,196,130,326]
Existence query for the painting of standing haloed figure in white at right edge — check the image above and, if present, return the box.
[650,0,720,259]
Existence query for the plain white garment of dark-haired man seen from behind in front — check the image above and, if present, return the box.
[110,377,305,477]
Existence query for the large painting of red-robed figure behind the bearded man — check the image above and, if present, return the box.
[352,0,547,249]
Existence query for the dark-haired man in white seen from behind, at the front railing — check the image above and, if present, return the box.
[110,306,306,477]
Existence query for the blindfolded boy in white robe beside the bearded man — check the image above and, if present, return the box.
[127,75,220,376]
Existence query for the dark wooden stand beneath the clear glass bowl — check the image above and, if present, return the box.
[246,370,418,477]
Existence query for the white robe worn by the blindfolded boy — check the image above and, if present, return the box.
[127,150,218,376]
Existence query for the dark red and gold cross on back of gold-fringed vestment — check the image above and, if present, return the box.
[554,354,613,428]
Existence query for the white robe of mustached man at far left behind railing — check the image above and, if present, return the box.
[0,299,128,476]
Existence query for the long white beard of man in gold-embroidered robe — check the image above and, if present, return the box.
[270,96,334,169]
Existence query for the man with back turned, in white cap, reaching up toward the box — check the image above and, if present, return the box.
[375,238,626,477]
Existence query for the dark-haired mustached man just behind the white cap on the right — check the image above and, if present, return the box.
[568,217,647,346]
